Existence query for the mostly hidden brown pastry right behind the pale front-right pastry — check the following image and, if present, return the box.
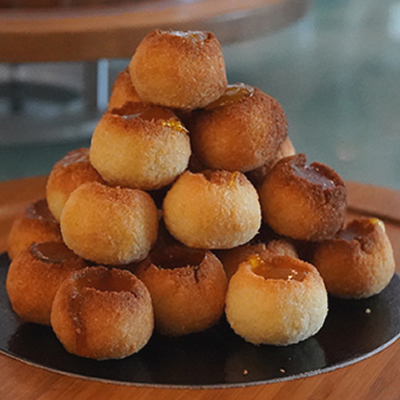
[217,239,298,279]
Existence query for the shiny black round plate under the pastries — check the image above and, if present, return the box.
[0,254,400,388]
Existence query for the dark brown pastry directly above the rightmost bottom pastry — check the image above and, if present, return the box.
[259,154,346,241]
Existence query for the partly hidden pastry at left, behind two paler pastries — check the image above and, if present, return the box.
[46,148,104,222]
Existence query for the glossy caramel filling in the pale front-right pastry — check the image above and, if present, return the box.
[247,254,306,282]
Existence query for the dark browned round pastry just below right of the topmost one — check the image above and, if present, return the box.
[189,84,288,172]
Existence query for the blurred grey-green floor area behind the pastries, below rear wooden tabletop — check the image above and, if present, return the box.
[0,0,400,189]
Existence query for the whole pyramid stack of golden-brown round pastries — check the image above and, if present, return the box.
[6,30,394,359]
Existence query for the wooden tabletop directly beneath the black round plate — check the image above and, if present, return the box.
[0,177,400,400]
